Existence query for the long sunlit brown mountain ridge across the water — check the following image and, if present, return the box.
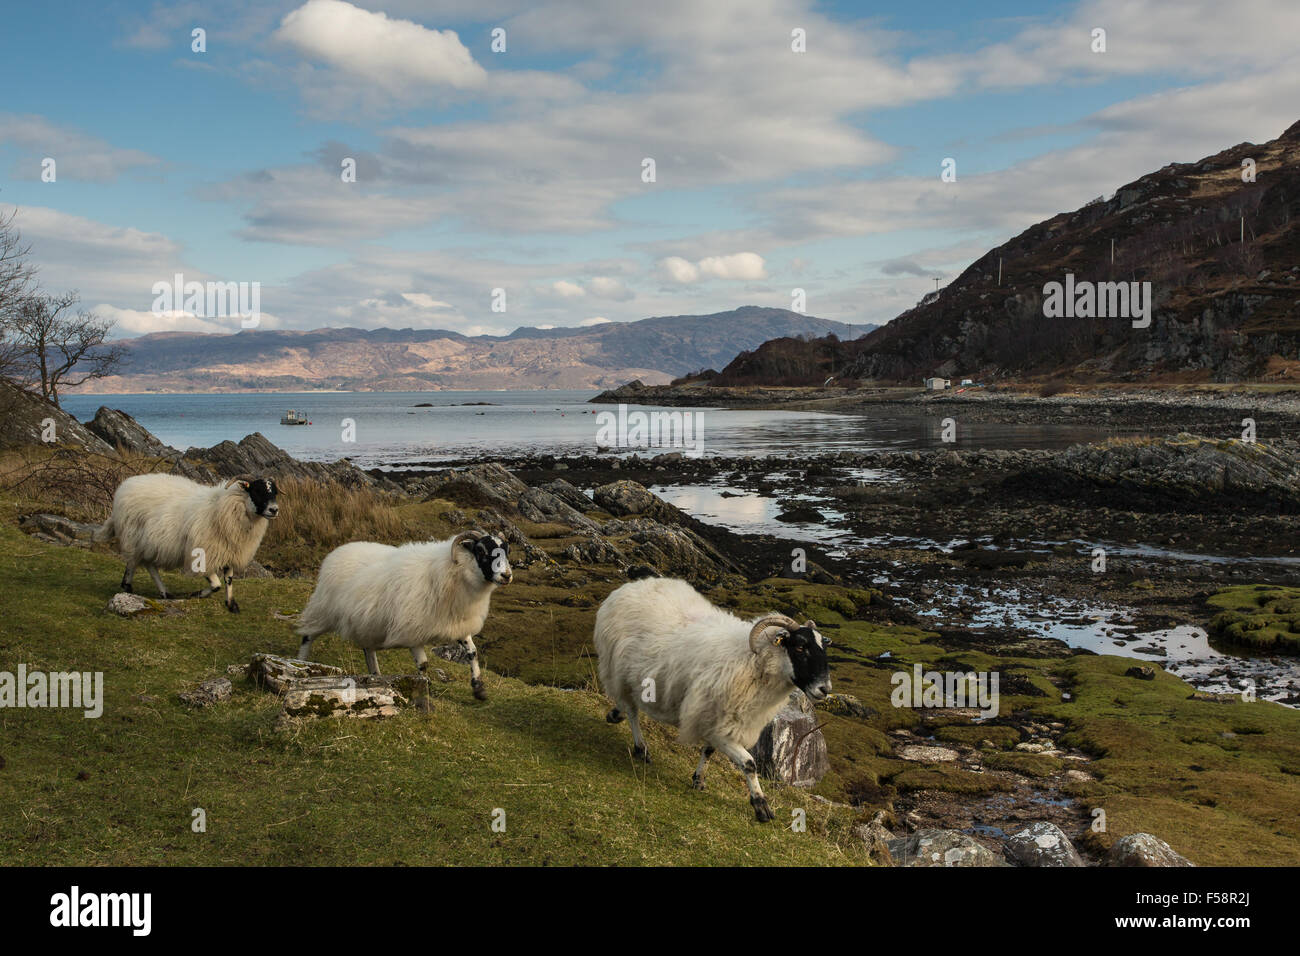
[68,306,874,393]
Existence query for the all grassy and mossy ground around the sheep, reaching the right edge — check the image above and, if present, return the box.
[0,470,1300,865]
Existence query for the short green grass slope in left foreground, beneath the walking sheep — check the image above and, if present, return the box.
[0,525,866,865]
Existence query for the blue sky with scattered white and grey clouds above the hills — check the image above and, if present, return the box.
[0,0,1300,334]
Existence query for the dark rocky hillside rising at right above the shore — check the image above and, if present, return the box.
[714,122,1300,385]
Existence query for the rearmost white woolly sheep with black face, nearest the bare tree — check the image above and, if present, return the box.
[94,475,280,614]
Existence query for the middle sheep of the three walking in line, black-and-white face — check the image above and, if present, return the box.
[298,531,514,700]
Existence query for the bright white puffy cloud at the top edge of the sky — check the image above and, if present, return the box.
[274,0,486,95]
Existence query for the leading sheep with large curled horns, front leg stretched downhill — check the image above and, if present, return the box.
[594,576,831,823]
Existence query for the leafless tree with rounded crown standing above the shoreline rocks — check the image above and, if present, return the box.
[5,291,126,407]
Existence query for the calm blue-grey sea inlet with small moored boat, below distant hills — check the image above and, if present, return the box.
[64,390,1104,467]
